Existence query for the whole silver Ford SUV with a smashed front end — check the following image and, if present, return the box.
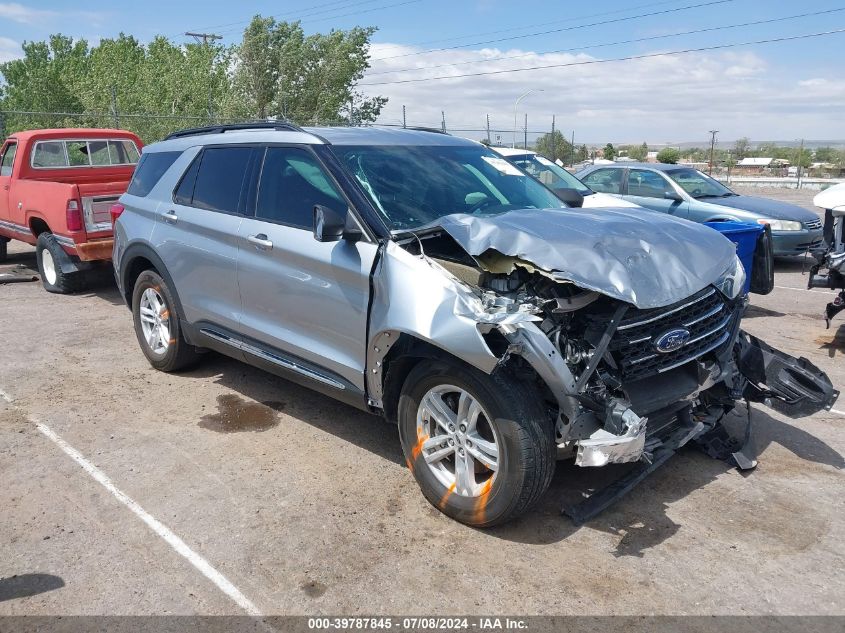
[114,123,833,526]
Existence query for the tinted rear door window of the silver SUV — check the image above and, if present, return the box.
[191,147,253,213]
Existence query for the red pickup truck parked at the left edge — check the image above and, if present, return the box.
[0,129,142,294]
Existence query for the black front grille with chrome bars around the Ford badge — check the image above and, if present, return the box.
[608,287,733,381]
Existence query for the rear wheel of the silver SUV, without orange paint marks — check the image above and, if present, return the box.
[132,270,198,371]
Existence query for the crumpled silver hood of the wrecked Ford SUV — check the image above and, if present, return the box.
[432,208,736,308]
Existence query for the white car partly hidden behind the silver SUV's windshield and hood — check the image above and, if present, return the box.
[490,147,641,209]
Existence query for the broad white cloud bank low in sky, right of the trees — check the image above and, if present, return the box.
[361,44,845,143]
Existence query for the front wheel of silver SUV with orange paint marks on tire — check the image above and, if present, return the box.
[398,360,555,527]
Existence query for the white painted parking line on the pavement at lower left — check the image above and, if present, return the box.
[0,391,262,617]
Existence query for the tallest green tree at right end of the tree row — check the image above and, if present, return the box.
[228,16,387,124]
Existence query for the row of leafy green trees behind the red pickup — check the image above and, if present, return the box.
[0,16,387,142]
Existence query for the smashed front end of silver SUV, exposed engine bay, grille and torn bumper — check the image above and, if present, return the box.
[370,207,834,520]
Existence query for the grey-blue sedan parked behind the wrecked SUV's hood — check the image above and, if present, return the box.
[576,163,822,256]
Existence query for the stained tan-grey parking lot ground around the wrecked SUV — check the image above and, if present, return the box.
[0,189,845,615]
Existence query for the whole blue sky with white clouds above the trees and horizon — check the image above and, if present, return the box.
[0,0,845,144]
